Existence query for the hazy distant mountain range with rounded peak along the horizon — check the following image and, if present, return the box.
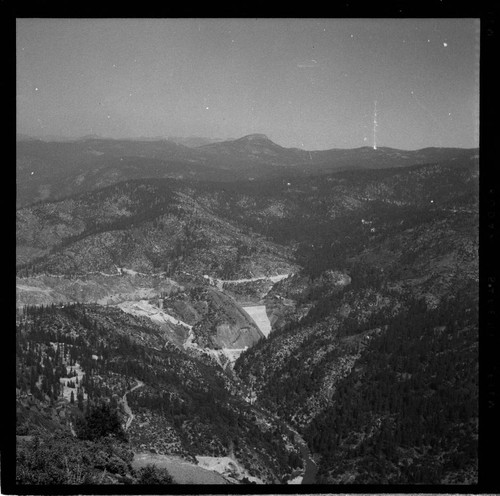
[16,134,478,206]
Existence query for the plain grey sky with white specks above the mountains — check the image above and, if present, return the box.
[16,18,480,150]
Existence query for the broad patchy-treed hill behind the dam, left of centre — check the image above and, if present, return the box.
[17,181,292,277]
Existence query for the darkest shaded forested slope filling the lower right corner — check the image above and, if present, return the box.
[307,288,478,484]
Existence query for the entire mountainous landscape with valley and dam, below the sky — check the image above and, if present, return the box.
[16,134,479,484]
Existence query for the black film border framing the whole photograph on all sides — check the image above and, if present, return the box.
[0,0,500,494]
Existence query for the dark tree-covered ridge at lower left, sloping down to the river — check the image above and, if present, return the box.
[17,304,298,482]
